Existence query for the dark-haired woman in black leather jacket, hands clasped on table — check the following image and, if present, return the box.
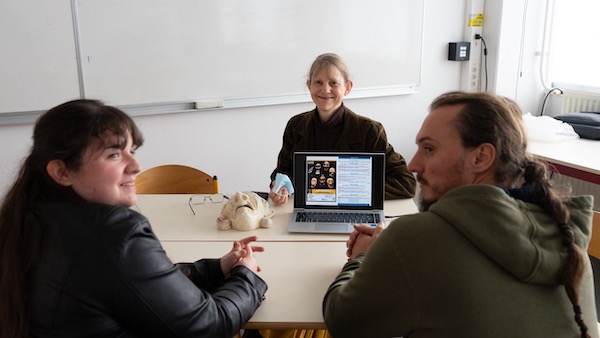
[0,99,267,338]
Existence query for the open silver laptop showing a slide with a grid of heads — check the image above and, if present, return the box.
[288,152,385,234]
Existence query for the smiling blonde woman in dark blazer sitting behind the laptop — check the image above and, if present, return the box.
[269,53,416,204]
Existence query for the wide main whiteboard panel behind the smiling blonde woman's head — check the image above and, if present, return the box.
[78,0,424,105]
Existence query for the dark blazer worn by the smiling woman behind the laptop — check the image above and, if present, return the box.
[271,107,416,199]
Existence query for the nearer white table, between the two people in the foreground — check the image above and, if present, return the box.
[162,242,347,329]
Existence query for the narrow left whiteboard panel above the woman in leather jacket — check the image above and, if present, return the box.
[0,0,80,113]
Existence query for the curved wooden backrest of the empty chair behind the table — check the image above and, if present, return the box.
[135,164,219,194]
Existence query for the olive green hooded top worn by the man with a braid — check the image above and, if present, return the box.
[323,185,598,338]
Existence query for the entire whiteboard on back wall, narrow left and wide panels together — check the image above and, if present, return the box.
[0,0,425,117]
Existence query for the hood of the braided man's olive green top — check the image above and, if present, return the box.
[429,185,593,285]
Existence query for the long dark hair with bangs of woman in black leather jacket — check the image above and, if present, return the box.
[0,99,144,337]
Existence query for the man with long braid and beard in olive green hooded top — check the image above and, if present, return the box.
[323,92,598,338]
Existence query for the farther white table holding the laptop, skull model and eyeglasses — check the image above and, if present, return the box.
[133,194,418,242]
